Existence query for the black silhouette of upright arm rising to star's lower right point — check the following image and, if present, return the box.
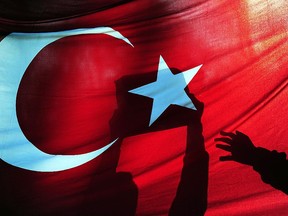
[169,98,209,216]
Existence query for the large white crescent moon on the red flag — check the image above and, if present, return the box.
[0,27,133,172]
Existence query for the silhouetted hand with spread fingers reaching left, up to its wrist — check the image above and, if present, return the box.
[215,131,256,165]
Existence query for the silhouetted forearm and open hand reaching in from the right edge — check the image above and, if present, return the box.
[215,131,288,194]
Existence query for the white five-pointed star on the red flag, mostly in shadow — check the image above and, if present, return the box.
[129,56,202,126]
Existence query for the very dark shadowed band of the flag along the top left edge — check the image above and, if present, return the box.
[0,0,131,22]
